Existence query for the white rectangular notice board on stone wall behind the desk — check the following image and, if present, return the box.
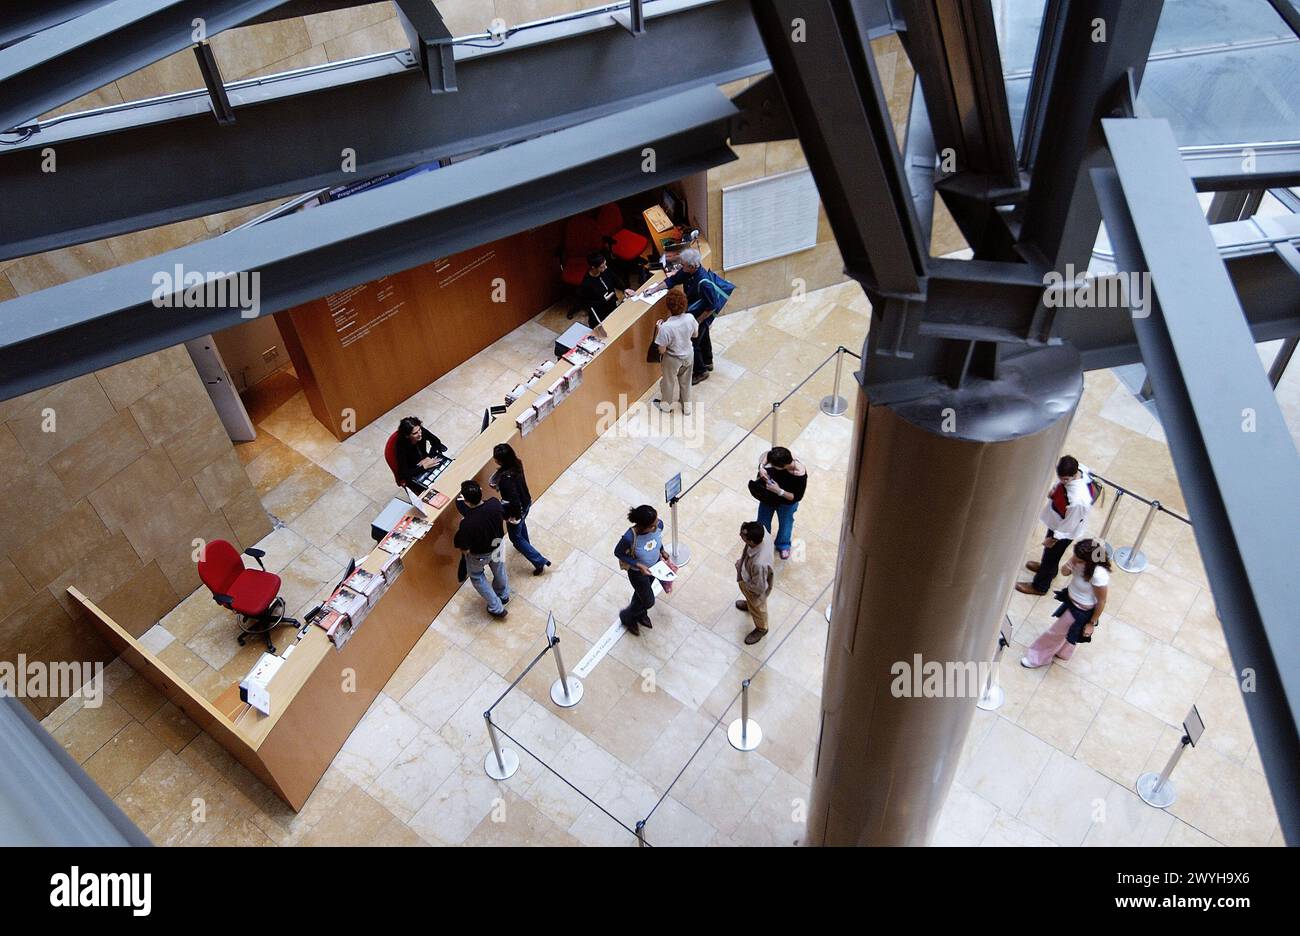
[723,169,818,270]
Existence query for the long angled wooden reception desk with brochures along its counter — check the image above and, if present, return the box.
[68,251,707,810]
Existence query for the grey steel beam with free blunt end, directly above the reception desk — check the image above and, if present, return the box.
[0,83,736,399]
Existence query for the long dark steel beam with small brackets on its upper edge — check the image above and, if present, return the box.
[0,0,767,259]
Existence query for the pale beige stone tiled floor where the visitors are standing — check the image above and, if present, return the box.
[38,285,1300,845]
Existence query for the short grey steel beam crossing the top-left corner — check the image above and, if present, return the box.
[0,0,292,129]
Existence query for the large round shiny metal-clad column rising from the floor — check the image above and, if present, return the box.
[807,347,1083,845]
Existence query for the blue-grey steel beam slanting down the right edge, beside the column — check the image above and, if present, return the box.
[1093,120,1300,845]
